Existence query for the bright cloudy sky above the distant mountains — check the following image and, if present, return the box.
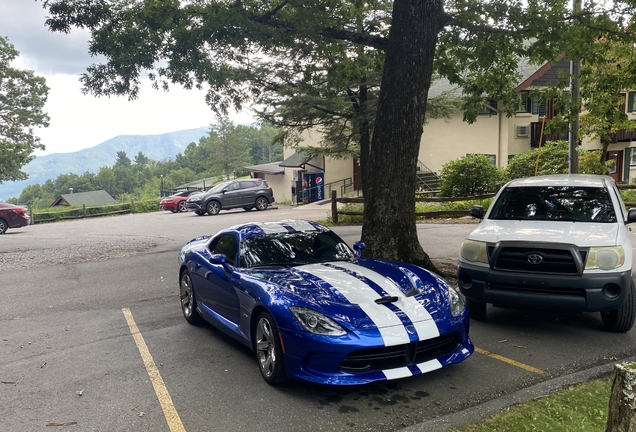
[0,0,253,155]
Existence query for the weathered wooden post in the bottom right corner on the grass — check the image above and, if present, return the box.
[605,363,636,432]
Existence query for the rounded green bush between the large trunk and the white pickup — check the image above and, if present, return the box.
[439,154,504,197]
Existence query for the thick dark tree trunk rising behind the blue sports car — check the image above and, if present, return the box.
[361,0,445,270]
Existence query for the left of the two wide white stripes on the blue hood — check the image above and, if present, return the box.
[299,264,410,346]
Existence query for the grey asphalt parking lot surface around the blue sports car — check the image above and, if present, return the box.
[0,206,636,432]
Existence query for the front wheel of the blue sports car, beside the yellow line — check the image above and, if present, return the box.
[254,312,287,385]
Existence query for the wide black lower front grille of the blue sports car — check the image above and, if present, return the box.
[340,333,462,373]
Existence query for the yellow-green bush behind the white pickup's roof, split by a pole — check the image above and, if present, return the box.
[506,141,609,180]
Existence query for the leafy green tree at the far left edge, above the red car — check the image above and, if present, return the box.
[0,36,49,183]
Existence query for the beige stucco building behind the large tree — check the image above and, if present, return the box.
[248,59,636,203]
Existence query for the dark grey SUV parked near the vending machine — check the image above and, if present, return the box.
[186,179,274,215]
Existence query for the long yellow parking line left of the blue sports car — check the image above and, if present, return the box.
[121,308,185,432]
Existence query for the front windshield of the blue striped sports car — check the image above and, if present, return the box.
[240,231,355,268]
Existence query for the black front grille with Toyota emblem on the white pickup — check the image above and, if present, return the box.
[489,246,587,274]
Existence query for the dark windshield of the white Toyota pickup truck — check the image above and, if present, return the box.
[489,186,616,223]
